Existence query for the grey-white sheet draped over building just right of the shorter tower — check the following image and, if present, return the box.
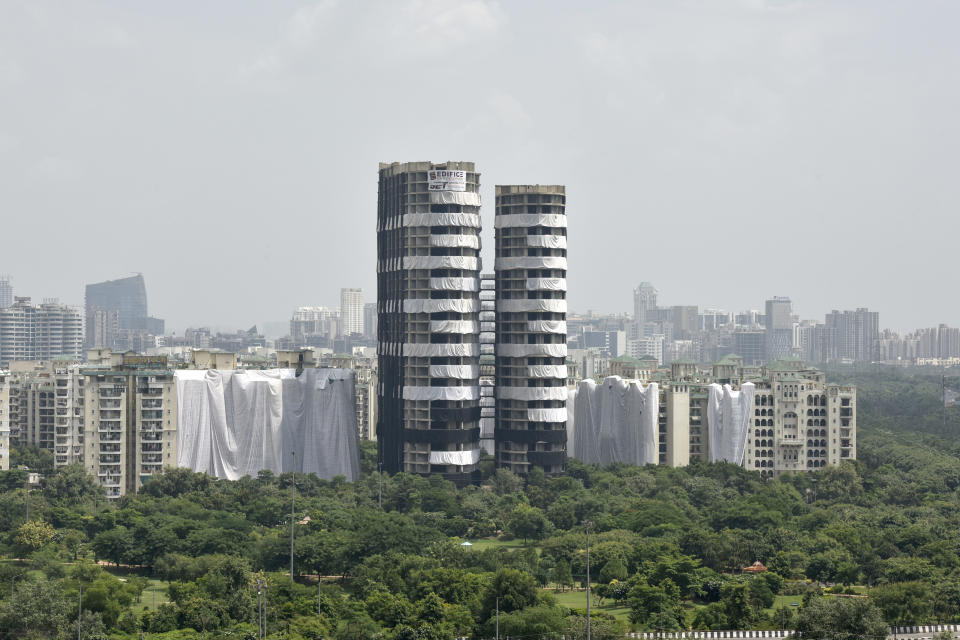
[567,376,659,465]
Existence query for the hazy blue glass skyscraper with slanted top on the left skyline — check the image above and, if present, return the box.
[84,274,164,348]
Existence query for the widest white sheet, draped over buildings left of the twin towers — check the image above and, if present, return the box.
[175,369,360,480]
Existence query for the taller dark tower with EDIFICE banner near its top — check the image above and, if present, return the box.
[377,162,481,484]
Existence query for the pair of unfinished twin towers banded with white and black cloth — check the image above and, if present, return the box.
[377,162,567,485]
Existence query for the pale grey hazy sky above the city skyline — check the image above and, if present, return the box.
[0,0,960,331]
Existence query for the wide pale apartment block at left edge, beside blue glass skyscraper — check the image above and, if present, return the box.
[0,297,83,368]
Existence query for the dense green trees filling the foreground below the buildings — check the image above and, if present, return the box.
[0,372,960,640]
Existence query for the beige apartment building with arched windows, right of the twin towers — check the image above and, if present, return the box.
[575,356,857,477]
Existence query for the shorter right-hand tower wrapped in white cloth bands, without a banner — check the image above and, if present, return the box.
[494,185,568,473]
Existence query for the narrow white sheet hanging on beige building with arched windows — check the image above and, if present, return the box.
[707,382,754,466]
